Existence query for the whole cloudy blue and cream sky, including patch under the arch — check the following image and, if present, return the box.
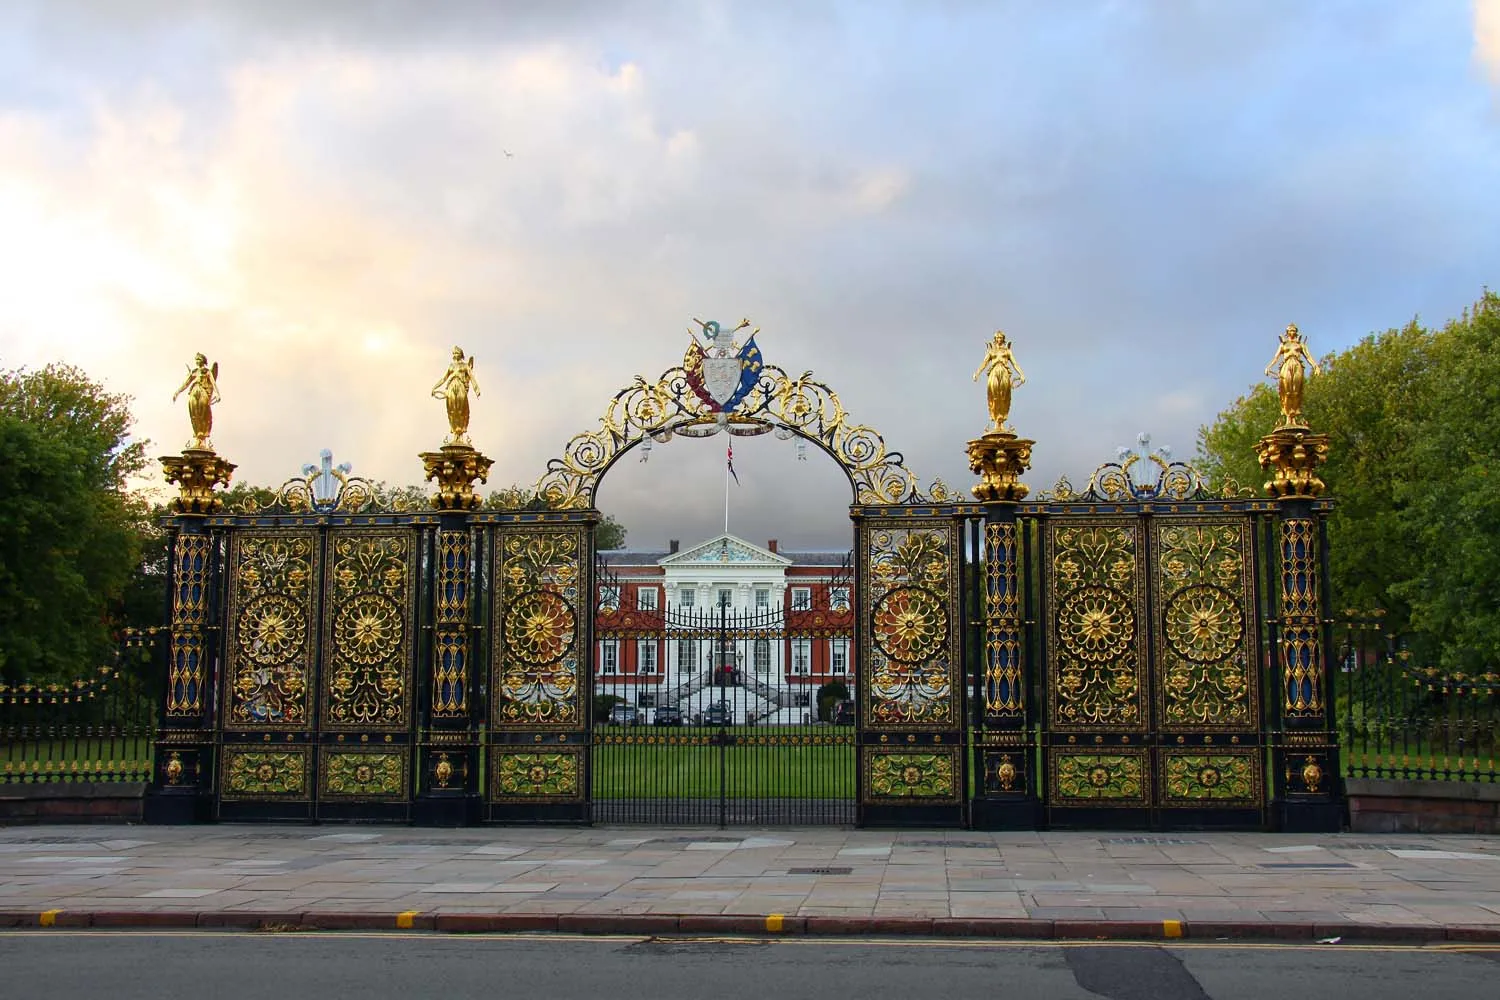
[0,0,1500,547]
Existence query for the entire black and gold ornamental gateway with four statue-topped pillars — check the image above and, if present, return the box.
[149,321,1343,831]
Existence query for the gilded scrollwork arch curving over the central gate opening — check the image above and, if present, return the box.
[536,353,960,510]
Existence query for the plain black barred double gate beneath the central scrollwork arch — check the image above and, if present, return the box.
[593,560,855,826]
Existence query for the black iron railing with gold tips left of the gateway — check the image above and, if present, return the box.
[0,631,161,784]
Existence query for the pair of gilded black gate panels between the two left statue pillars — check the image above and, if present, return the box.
[218,519,420,819]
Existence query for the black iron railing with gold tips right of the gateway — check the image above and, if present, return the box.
[1335,615,1500,783]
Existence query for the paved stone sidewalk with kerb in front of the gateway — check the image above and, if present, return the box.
[0,826,1500,942]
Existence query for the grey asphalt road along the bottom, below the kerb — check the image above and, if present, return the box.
[0,931,1500,1000]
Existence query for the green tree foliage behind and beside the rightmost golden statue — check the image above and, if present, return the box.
[1199,291,1500,669]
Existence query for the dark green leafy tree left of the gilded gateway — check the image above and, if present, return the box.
[0,364,147,682]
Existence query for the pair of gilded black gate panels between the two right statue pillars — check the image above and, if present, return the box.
[1043,514,1266,829]
